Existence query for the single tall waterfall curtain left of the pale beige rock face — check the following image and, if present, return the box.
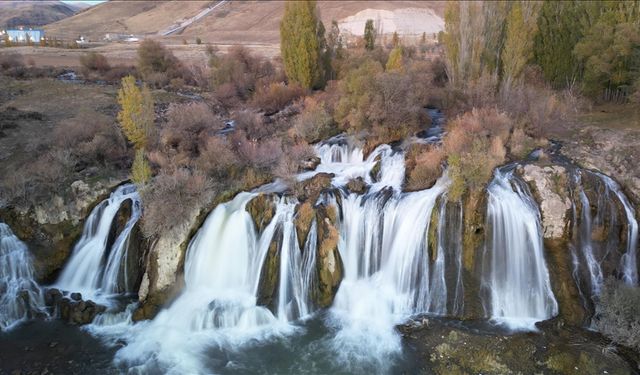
[482,169,558,329]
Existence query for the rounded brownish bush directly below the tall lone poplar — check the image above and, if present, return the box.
[294,98,338,143]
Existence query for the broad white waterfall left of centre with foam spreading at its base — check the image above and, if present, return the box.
[116,193,294,373]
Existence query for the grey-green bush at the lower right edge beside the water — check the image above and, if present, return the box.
[594,278,640,350]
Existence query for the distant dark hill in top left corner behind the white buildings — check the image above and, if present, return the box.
[0,1,80,28]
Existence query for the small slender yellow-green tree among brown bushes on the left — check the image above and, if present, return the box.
[118,75,155,150]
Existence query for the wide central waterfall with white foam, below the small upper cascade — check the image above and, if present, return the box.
[331,176,449,369]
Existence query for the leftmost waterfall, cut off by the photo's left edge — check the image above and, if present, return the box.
[0,223,44,331]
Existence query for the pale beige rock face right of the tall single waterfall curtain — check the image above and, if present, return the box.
[522,164,571,239]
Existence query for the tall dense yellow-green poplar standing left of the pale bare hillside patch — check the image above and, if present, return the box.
[280,0,326,88]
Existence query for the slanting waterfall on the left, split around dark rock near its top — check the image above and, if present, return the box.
[56,184,141,298]
